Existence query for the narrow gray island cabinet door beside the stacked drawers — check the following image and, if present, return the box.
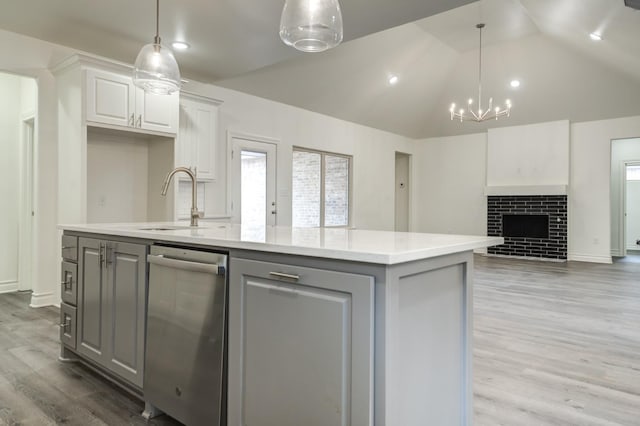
[76,238,108,365]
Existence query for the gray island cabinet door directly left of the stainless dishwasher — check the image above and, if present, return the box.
[105,241,147,387]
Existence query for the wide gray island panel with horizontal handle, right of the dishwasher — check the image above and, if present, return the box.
[228,259,374,426]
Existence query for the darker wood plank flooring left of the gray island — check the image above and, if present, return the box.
[0,293,179,426]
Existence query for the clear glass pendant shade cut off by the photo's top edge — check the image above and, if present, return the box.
[280,0,342,52]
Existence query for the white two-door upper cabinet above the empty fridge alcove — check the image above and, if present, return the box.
[86,69,179,134]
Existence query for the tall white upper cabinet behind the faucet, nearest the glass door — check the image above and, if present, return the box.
[175,93,220,180]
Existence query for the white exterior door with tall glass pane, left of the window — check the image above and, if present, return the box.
[229,136,277,228]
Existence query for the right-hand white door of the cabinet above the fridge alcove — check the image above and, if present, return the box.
[136,88,180,133]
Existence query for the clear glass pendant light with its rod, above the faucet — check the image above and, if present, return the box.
[133,0,180,95]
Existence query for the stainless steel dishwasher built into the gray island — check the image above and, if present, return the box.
[143,245,227,426]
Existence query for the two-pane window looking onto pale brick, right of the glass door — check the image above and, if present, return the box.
[291,148,351,227]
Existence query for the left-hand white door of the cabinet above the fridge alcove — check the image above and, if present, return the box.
[86,69,136,127]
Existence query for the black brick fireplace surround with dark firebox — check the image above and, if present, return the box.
[487,195,567,260]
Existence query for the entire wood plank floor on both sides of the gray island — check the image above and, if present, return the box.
[0,256,640,426]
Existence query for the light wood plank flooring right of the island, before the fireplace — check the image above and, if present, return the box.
[474,256,640,425]
